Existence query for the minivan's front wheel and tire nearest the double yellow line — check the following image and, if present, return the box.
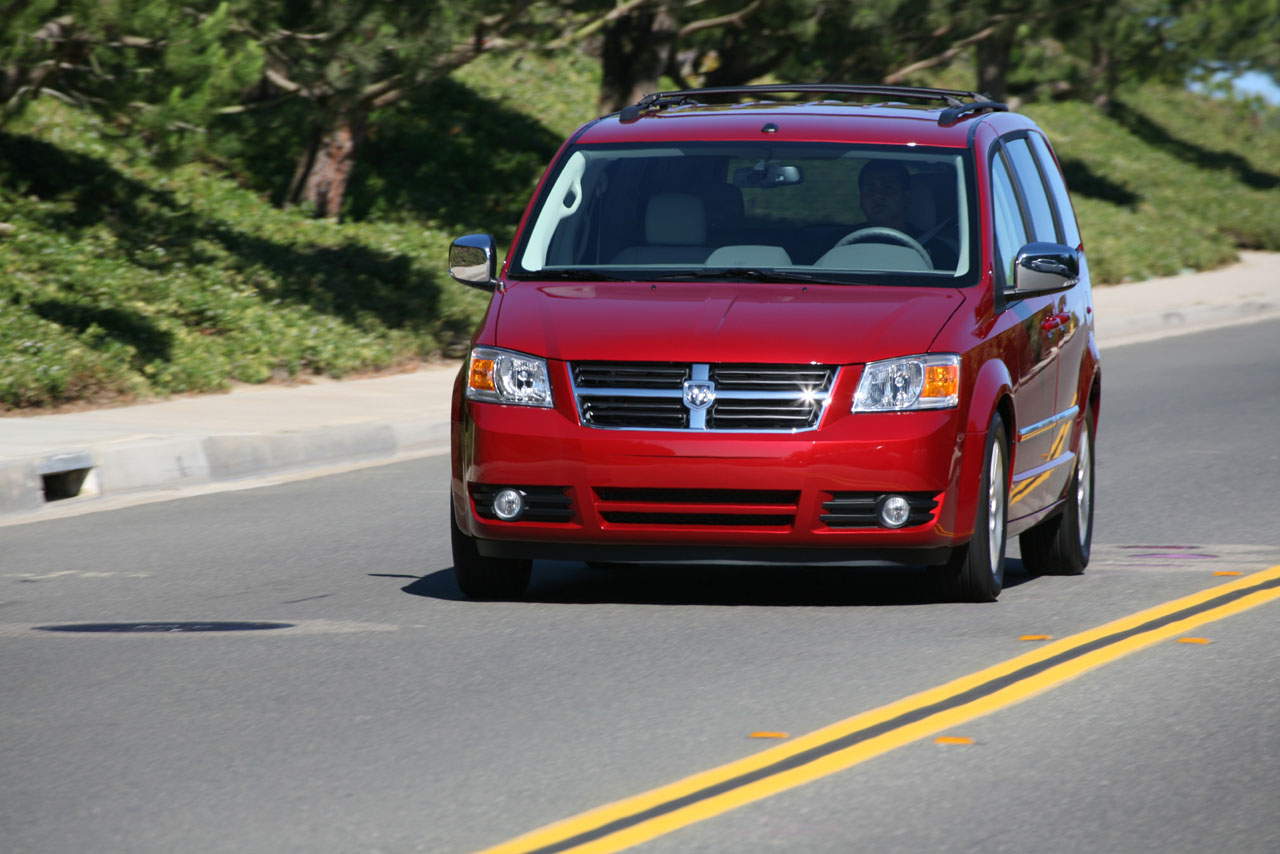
[932,412,1009,602]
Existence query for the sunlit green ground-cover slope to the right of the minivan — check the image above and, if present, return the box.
[1024,86,1280,283]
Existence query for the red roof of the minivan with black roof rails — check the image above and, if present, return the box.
[576,86,1030,147]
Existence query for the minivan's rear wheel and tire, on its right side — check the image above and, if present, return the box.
[1018,412,1093,575]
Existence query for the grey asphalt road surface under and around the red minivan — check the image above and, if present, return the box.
[0,321,1280,854]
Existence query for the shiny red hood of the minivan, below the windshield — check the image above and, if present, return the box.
[493,282,964,365]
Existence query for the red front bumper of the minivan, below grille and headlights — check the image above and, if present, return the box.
[452,389,983,563]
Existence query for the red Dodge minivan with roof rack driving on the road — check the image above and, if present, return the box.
[449,85,1101,602]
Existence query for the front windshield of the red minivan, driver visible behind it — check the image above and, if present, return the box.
[511,142,977,287]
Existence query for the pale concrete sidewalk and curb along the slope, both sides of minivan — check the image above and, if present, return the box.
[0,252,1280,521]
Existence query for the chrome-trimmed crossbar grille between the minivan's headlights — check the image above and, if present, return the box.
[571,362,837,433]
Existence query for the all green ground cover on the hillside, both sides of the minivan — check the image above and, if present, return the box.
[0,42,1280,408]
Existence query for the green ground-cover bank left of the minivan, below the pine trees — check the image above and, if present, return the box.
[0,102,484,407]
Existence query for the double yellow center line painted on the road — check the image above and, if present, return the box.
[481,566,1280,854]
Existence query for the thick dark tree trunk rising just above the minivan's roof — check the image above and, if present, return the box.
[600,8,676,113]
